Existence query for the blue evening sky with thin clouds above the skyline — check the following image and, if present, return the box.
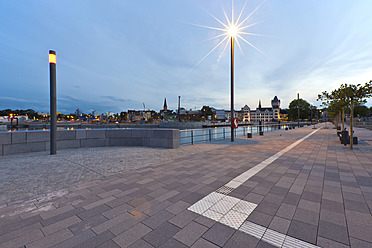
[0,0,372,113]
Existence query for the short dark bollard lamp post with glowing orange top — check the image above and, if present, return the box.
[49,50,57,155]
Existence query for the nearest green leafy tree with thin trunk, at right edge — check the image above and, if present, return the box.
[317,80,372,149]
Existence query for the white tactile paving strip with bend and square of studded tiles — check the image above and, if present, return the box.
[188,128,320,248]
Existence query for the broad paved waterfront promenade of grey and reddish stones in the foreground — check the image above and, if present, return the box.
[0,124,372,248]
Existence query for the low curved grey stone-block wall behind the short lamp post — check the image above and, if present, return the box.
[0,129,180,156]
